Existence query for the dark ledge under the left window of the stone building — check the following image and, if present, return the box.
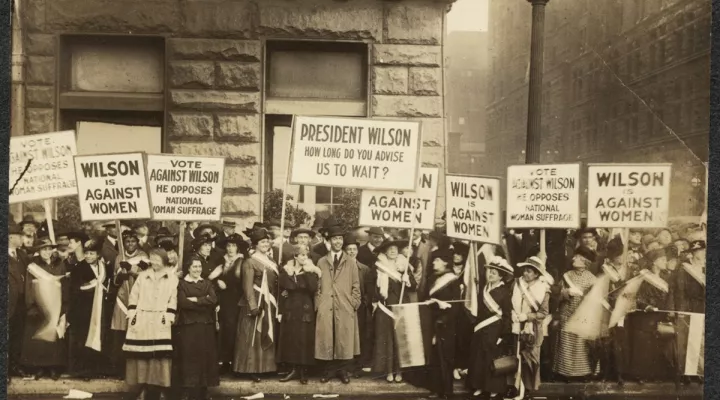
[60,92,165,111]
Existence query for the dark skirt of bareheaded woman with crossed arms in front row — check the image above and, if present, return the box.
[178,324,220,388]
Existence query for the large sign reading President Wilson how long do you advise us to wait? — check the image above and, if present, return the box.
[290,117,420,190]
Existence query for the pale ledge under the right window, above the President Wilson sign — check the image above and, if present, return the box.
[265,98,367,117]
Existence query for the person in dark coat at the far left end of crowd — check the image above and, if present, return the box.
[7,222,28,377]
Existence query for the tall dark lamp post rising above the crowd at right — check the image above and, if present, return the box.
[525,0,550,164]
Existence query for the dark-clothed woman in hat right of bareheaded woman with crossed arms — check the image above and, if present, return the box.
[216,233,249,373]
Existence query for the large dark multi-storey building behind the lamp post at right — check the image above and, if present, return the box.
[486,0,711,216]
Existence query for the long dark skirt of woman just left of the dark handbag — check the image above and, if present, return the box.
[468,322,510,393]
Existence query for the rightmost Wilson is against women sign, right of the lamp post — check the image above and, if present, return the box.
[588,164,672,228]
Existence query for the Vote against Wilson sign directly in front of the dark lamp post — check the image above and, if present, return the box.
[505,164,580,229]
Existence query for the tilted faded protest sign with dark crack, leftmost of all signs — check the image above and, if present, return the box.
[9,131,77,204]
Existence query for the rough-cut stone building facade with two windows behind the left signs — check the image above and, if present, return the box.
[13,0,454,222]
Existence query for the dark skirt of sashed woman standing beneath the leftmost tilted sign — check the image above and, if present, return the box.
[20,314,68,368]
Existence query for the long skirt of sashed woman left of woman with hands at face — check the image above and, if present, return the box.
[233,309,278,374]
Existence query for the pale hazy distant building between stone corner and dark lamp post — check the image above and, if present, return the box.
[445,31,488,174]
